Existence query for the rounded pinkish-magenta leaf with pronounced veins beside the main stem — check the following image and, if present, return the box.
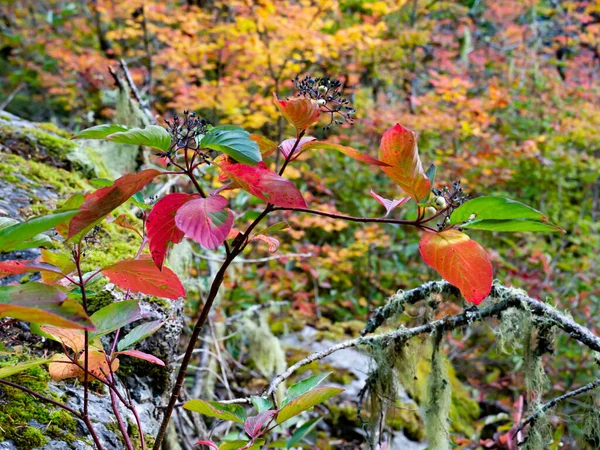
[175,195,233,249]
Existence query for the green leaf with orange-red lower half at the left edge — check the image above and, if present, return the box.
[0,283,94,331]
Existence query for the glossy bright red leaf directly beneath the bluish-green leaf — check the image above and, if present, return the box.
[219,160,306,208]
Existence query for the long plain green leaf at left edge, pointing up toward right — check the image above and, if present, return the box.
[0,210,79,252]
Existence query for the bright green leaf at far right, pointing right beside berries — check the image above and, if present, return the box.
[450,197,562,231]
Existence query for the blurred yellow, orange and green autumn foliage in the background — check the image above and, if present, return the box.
[0,0,600,448]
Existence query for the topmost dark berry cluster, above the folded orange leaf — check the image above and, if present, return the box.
[292,76,355,130]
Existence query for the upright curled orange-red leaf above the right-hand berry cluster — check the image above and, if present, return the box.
[379,124,431,201]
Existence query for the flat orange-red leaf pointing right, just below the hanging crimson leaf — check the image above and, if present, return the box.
[102,259,185,300]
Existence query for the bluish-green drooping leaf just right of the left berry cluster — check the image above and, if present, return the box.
[200,130,262,166]
